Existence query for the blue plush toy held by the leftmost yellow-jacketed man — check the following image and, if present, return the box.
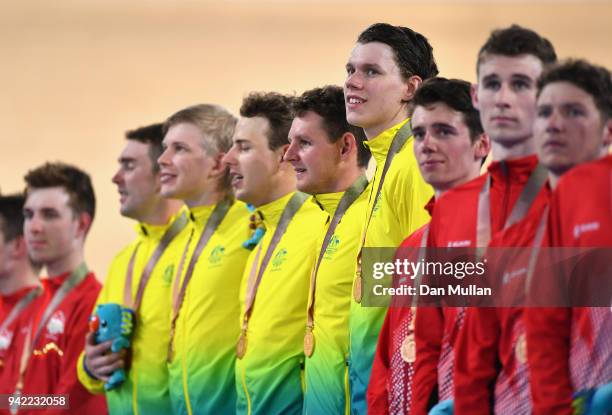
[89,303,134,391]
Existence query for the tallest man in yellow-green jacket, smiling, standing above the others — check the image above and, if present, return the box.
[344,23,438,414]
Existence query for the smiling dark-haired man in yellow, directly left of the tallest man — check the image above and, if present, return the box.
[285,86,370,414]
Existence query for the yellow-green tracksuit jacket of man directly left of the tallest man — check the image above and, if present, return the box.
[304,187,370,415]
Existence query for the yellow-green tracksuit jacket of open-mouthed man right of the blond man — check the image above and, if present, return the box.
[236,193,325,415]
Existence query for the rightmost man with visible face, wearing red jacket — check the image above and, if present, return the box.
[455,62,609,413]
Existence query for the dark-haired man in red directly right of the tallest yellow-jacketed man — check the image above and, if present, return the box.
[367,78,489,415]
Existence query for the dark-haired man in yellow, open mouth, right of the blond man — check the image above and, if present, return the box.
[225,92,327,415]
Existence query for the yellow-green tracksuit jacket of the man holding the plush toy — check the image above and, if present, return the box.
[77,212,187,415]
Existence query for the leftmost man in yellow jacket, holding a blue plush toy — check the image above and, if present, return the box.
[77,124,187,415]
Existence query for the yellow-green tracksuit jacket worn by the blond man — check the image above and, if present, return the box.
[168,201,250,415]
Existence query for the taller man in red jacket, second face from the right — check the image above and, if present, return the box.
[413,26,556,414]
